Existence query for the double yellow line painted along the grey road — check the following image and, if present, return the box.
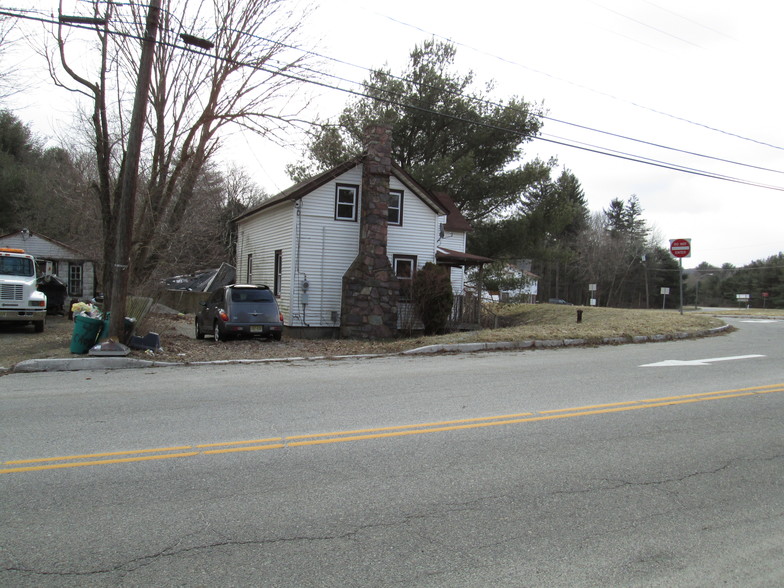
[0,384,784,474]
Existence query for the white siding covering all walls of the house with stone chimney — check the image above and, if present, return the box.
[237,165,465,327]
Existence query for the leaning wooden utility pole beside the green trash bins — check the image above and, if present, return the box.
[109,0,161,342]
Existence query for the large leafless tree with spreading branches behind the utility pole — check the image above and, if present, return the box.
[48,0,308,298]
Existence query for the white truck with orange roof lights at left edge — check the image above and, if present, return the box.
[0,247,46,333]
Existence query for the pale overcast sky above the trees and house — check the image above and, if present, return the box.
[7,0,784,267]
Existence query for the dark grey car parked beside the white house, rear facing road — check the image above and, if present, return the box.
[195,284,283,341]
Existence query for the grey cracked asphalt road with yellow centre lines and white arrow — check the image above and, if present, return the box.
[0,320,784,586]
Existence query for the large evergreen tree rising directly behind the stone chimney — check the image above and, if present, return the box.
[289,41,552,221]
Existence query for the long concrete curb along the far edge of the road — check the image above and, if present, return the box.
[0,325,730,373]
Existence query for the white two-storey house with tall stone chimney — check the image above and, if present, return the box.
[235,127,491,337]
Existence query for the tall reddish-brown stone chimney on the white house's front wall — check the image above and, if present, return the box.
[340,125,400,339]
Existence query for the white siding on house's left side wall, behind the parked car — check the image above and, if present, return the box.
[237,202,296,325]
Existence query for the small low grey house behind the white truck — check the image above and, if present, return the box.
[0,229,95,299]
